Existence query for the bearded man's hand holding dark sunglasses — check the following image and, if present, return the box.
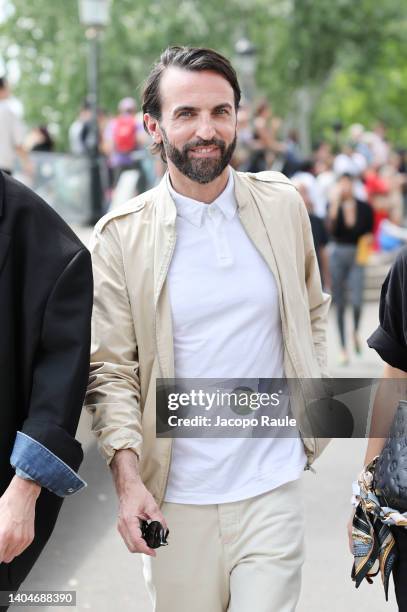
[111,449,167,557]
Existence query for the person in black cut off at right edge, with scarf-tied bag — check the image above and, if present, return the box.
[348,248,407,612]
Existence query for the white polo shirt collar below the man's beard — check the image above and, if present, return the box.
[166,169,237,227]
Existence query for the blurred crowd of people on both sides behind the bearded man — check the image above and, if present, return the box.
[0,79,407,364]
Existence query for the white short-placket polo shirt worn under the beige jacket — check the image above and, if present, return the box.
[165,167,306,504]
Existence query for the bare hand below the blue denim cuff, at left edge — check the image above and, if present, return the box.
[0,476,41,563]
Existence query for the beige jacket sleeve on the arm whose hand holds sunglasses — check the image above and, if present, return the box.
[86,221,142,464]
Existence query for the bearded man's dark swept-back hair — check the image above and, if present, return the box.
[142,47,241,161]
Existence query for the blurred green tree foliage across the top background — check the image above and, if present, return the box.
[0,0,407,147]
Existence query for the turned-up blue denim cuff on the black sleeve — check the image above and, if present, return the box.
[10,431,87,497]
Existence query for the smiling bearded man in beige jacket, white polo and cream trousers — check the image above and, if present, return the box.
[87,47,329,612]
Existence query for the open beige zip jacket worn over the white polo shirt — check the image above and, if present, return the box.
[85,170,330,505]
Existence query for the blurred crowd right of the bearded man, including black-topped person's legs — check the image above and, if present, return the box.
[234,101,407,365]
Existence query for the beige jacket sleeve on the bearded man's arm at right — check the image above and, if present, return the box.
[299,196,331,377]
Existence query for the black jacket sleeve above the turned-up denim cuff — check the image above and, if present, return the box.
[21,248,93,471]
